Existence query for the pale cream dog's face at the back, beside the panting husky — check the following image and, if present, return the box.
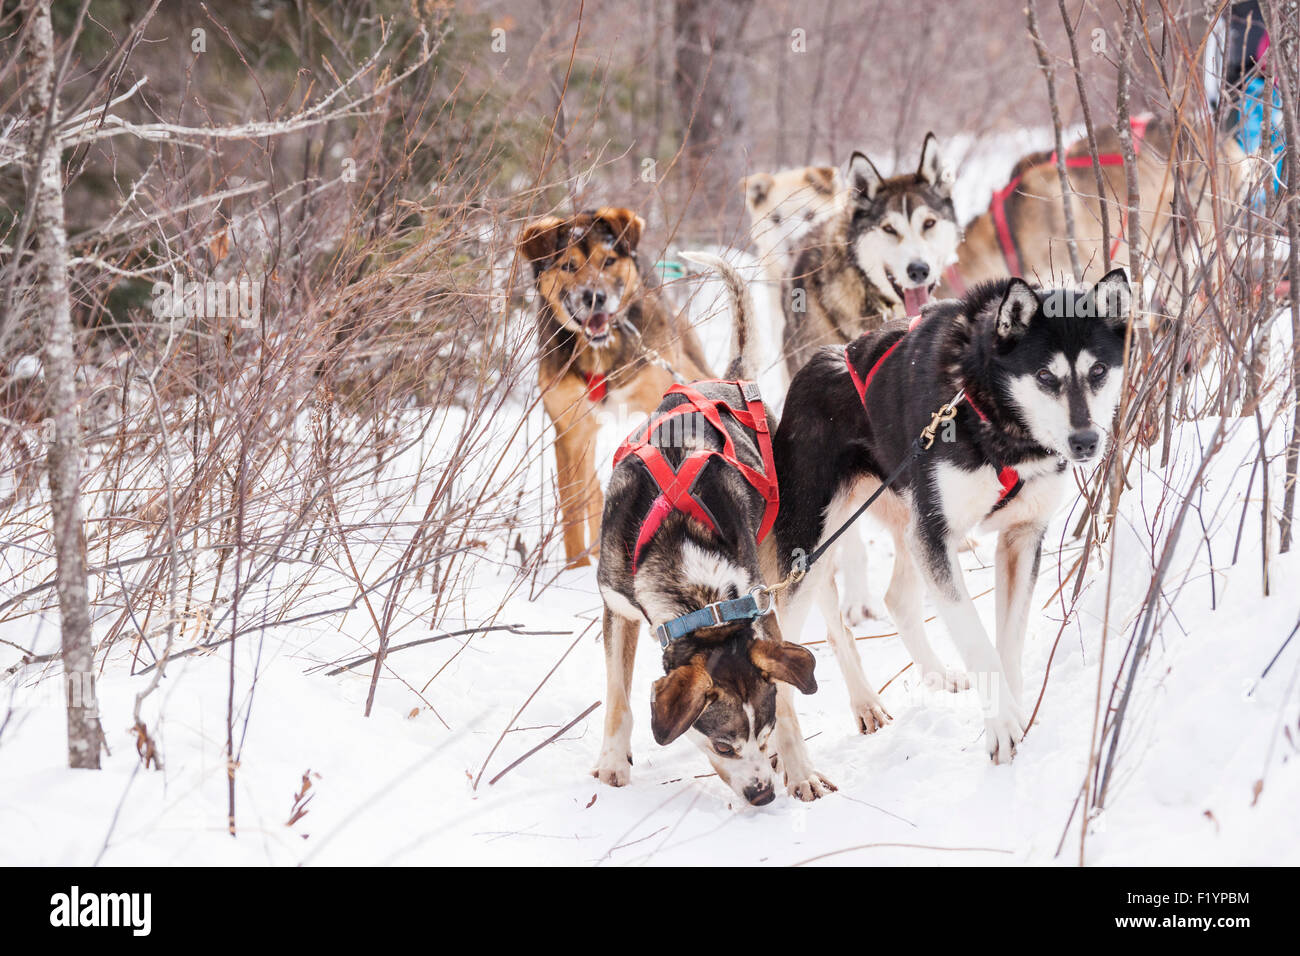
[740,166,844,265]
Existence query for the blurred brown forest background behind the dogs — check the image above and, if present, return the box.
[0,0,1180,340]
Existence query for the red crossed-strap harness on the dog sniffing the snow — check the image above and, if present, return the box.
[614,380,780,574]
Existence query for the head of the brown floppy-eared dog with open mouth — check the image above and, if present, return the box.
[519,207,645,347]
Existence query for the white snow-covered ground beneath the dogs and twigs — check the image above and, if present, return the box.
[0,130,1300,865]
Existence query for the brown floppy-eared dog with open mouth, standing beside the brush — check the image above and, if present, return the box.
[519,207,712,567]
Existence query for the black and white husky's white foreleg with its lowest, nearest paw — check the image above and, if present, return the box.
[914,530,1026,763]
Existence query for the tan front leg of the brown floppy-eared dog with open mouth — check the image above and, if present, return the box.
[542,376,605,567]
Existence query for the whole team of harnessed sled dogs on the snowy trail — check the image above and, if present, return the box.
[519,120,1239,805]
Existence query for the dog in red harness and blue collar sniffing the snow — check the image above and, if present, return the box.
[593,254,835,805]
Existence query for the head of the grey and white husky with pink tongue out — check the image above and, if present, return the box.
[848,133,961,315]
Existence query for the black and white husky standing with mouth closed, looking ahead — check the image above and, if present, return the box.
[764,269,1130,762]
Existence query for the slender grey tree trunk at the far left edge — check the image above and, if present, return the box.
[26,0,103,770]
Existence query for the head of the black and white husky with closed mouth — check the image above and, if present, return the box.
[993,269,1131,463]
